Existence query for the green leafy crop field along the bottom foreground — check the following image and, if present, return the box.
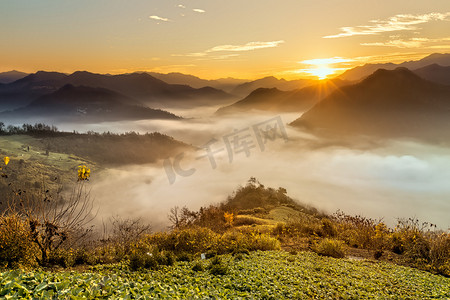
[0,251,450,299]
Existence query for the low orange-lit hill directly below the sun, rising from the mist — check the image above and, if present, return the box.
[217,79,352,115]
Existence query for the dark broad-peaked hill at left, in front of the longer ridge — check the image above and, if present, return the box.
[0,84,179,122]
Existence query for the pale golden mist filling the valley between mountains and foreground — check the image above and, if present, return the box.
[40,108,450,230]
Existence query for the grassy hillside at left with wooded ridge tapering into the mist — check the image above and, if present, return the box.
[0,129,192,211]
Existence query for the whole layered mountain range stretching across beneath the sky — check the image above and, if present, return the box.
[0,54,450,130]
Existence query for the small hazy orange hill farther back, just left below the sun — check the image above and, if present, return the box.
[231,76,314,97]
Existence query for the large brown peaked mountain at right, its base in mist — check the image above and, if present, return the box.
[291,68,450,140]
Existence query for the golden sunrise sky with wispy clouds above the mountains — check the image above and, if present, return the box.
[0,0,450,79]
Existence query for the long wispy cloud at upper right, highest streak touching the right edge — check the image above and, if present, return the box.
[323,12,450,39]
